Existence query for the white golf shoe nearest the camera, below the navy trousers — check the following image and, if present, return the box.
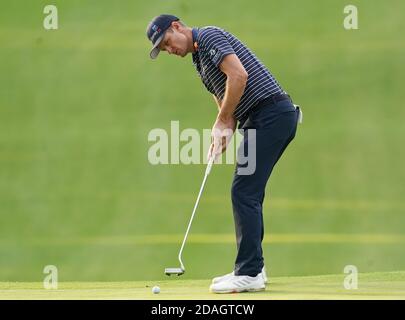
[210,273,266,293]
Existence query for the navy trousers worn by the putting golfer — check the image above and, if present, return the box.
[232,100,299,277]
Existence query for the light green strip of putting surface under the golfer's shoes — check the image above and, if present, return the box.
[0,271,405,300]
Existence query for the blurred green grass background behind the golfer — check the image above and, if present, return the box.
[0,0,405,281]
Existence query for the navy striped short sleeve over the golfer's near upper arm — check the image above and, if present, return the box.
[201,28,235,67]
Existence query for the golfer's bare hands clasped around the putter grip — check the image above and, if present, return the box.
[207,116,236,160]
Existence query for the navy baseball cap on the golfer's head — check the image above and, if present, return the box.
[146,14,180,59]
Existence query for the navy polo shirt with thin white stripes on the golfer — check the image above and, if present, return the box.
[192,26,284,120]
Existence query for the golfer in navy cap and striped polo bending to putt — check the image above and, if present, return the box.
[146,14,301,293]
